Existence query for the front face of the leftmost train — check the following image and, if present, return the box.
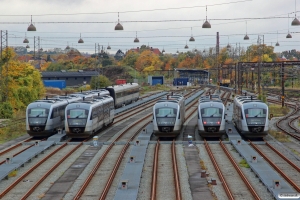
[26,102,52,137]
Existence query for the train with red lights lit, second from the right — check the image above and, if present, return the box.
[197,95,226,137]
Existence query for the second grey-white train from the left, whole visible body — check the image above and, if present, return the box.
[65,95,115,138]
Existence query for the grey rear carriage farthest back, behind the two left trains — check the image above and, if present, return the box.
[105,83,140,108]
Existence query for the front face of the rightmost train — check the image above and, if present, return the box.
[241,102,269,137]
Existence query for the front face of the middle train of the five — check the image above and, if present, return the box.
[153,102,180,137]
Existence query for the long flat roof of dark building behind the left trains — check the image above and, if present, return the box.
[41,70,99,78]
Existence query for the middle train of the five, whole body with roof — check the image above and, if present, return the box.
[153,94,185,137]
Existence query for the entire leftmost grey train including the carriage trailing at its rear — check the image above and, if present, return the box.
[26,83,139,137]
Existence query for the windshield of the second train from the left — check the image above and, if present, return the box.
[67,109,89,126]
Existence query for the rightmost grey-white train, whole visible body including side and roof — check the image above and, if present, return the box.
[232,96,269,138]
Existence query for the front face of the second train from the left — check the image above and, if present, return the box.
[65,103,92,138]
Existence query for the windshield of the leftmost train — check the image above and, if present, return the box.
[28,107,49,125]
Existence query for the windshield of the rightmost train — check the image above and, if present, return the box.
[245,108,267,125]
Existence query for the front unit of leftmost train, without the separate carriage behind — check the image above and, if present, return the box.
[26,89,109,137]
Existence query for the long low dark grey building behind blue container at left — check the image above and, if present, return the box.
[41,70,99,87]
